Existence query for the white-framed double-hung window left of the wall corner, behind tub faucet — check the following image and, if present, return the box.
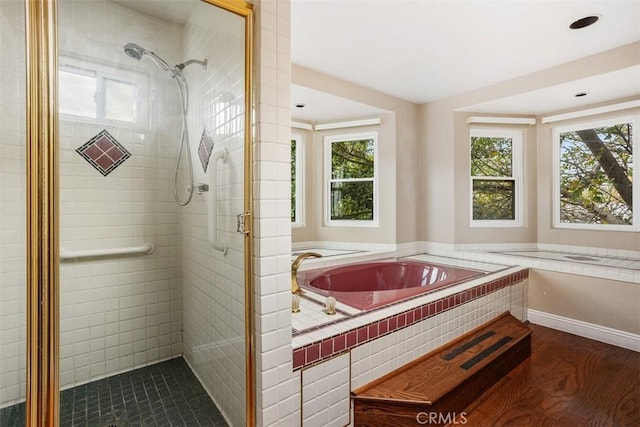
[325,132,378,226]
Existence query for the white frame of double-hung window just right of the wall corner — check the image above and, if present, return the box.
[468,128,525,228]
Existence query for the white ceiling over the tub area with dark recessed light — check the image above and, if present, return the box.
[291,0,640,116]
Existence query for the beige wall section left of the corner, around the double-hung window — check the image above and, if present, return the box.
[292,65,418,244]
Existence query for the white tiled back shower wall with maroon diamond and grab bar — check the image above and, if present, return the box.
[59,0,182,387]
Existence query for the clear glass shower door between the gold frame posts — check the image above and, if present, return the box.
[58,0,254,425]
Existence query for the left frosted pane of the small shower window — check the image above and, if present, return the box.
[58,70,97,119]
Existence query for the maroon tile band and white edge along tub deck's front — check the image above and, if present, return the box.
[293,255,528,370]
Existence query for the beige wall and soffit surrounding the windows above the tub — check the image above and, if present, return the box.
[292,42,640,250]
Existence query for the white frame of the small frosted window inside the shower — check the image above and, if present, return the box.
[58,55,150,130]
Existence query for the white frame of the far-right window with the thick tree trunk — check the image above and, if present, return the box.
[551,115,640,232]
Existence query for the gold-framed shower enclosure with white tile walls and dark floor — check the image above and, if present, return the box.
[0,0,253,426]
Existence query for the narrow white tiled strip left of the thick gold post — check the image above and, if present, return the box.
[0,0,26,407]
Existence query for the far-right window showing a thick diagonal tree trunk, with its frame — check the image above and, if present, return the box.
[553,118,640,230]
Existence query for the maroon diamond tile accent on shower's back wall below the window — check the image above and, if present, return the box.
[76,129,131,176]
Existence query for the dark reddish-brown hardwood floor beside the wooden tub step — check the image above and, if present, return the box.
[456,325,640,427]
